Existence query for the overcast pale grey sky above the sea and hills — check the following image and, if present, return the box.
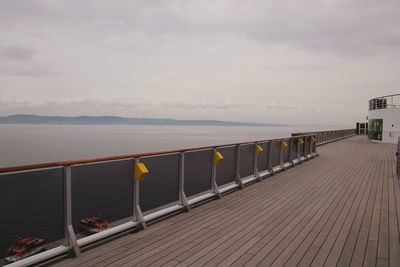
[0,0,400,126]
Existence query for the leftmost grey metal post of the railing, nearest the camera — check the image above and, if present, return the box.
[64,166,81,257]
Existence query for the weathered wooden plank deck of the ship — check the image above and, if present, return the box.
[57,136,400,266]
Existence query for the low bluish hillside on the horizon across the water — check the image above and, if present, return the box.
[0,114,285,127]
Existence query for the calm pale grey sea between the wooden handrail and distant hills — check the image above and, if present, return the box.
[0,125,344,168]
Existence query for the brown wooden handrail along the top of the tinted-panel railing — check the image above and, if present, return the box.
[0,133,315,173]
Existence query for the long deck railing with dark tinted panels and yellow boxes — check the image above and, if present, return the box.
[0,131,318,266]
